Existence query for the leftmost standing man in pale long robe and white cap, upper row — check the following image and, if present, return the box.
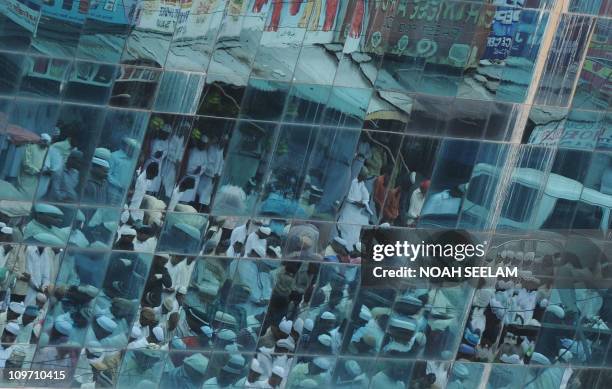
[17,134,51,200]
